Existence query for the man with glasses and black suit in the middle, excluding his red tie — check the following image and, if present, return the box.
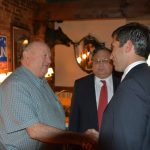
[69,47,120,132]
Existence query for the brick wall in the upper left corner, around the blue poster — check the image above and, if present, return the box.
[0,0,35,73]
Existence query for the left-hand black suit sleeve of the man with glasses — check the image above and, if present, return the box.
[69,81,80,132]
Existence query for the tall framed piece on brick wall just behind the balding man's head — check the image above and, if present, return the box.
[12,26,30,70]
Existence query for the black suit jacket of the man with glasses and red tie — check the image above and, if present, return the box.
[69,74,120,132]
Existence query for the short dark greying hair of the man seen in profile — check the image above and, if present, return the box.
[112,22,150,59]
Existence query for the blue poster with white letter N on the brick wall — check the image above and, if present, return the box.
[0,35,8,72]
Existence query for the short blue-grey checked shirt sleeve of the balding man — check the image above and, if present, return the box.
[1,80,39,133]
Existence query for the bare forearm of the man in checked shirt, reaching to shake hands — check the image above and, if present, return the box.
[27,124,93,145]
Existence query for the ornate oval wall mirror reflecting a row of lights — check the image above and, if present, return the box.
[74,34,105,73]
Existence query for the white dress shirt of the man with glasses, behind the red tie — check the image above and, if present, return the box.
[95,75,114,108]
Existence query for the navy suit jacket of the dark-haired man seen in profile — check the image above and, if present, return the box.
[98,64,150,150]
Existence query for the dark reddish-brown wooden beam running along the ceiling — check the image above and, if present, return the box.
[35,0,150,21]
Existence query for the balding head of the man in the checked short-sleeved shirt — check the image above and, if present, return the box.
[21,41,51,78]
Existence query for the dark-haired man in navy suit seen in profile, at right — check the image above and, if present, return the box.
[98,23,150,150]
